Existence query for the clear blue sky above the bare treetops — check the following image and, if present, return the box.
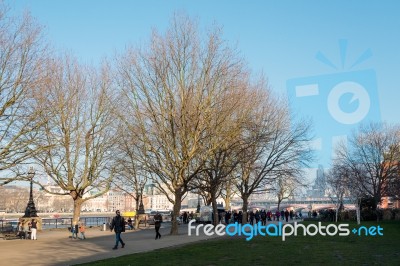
[5,0,400,179]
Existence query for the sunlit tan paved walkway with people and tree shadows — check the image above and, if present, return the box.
[0,224,220,265]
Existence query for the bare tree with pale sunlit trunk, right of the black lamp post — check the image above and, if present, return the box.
[31,57,115,222]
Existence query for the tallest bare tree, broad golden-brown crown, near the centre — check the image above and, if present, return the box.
[115,15,252,234]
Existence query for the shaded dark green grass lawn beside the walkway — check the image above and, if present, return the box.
[79,222,400,266]
